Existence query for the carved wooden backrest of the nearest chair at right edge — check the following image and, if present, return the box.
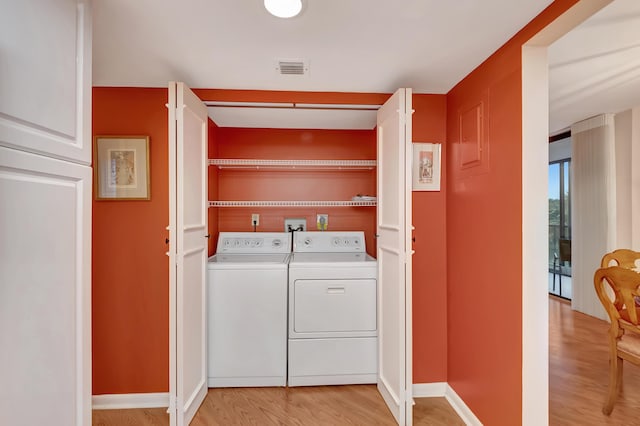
[593,266,640,335]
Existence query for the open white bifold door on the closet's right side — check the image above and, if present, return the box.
[377,89,413,425]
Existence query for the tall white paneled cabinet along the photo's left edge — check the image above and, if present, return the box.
[0,0,92,426]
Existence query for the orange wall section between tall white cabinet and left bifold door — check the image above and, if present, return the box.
[92,88,169,395]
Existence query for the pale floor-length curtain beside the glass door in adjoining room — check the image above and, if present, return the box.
[571,114,616,319]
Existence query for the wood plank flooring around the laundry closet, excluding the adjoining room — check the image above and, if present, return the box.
[93,385,464,426]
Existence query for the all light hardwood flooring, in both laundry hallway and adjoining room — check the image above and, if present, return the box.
[93,297,640,426]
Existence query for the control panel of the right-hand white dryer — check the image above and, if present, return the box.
[293,231,366,253]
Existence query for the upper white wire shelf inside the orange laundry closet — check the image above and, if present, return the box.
[209,158,376,170]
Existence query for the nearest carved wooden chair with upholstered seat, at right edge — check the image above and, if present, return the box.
[593,266,640,415]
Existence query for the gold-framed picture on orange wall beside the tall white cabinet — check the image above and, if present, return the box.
[93,136,151,200]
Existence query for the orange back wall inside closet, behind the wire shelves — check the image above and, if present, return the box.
[210,128,376,254]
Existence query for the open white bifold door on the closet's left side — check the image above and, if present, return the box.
[168,82,209,426]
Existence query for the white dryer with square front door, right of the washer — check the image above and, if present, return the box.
[287,231,378,386]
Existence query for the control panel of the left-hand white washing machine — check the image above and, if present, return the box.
[216,232,291,254]
